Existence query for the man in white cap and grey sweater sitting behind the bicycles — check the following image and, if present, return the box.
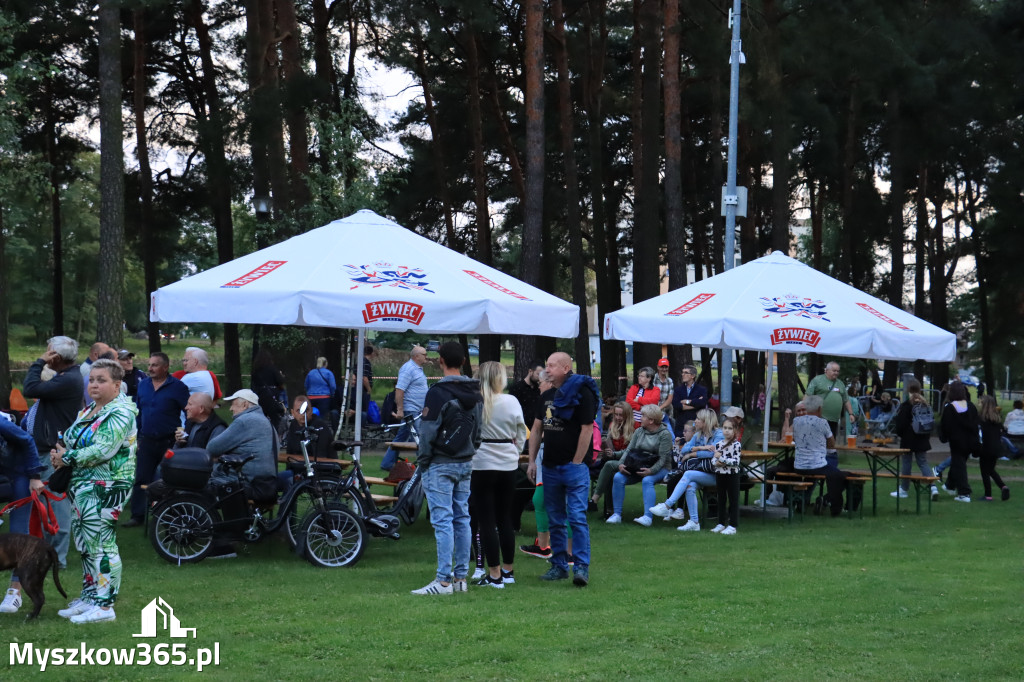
[206,388,279,481]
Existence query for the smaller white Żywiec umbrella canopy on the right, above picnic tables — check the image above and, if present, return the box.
[604,246,956,363]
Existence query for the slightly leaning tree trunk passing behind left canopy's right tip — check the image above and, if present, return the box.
[551,0,591,376]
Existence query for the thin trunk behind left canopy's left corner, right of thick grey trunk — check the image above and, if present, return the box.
[132,8,161,355]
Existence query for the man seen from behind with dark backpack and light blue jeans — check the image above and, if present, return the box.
[413,341,481,594]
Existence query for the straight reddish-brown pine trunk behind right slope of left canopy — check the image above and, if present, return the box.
[515,0,544,376]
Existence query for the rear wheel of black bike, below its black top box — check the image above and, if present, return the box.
[150,495,217,563]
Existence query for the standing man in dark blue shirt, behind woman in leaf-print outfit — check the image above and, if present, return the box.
[124,352,188,528]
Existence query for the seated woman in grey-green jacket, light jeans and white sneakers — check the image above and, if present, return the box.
[606,404,672,526]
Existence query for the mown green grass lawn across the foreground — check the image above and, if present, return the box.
[0,448,1024,681]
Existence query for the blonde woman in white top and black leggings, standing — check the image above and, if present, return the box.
[470,361,526,588]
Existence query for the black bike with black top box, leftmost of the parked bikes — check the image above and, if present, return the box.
[150,404,367,567]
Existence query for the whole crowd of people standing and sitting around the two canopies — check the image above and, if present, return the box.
[6,336,1024,606]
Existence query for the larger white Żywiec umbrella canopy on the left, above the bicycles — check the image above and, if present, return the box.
[150,210,580,338]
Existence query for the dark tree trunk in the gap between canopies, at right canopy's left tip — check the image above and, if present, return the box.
[583,0,624,395]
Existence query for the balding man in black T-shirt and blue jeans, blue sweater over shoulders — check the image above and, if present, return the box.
[526,352,598,587]
